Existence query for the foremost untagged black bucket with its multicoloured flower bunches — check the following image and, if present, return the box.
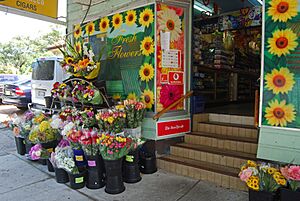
[100,133,132,194]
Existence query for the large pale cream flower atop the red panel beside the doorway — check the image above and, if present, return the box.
[158,9,182,42]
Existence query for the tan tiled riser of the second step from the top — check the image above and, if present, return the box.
[196,123,258,139]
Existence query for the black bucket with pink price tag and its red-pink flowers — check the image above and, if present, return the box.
[79,129,105,189]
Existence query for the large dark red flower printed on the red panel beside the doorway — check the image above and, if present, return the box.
[160,85,182,109]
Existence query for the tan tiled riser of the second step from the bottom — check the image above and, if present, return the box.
[171,146,247,168]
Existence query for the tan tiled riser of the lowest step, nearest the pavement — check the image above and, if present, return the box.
[157,159,247,191]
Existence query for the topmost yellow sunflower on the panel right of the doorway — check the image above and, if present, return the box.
[268,0,298,22]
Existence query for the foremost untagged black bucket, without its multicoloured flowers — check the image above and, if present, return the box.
[104,158,125,194]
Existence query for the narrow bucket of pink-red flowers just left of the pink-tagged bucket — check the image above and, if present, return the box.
[67,128,86,167]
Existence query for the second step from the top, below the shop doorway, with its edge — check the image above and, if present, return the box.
[193,121,258,139]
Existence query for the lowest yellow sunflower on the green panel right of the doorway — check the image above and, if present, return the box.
[265,100,296,127]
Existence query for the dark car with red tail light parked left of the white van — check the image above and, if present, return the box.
[2,79,31,109]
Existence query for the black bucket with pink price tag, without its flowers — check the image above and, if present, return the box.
[86,155,105,189]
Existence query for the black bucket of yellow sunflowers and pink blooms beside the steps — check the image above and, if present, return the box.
[239,160,286,201]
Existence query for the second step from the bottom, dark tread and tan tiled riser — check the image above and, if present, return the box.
[170,143,256,168]
